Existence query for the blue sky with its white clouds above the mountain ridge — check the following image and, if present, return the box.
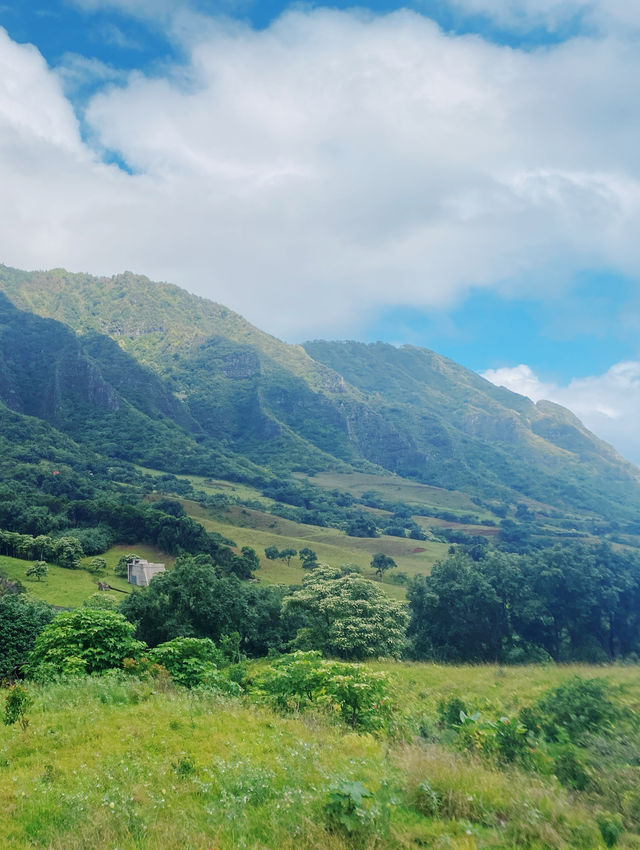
[0,0,640,463]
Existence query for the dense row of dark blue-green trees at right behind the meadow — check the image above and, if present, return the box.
[407,544,640,663]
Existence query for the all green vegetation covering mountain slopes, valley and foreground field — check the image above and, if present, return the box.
[6,267,640,850]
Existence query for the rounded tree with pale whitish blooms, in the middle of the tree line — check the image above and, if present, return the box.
[283,567,409,659]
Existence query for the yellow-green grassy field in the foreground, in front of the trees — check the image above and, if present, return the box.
[0,664,640,850]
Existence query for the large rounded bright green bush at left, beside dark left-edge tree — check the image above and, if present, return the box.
[27,608,144,680]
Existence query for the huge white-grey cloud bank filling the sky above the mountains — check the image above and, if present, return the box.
[0,10,640,339]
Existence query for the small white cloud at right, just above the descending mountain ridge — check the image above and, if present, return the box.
[483,360,640,464]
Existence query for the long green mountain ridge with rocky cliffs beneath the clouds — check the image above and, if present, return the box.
[0,266,640,520]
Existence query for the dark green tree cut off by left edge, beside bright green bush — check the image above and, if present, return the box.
[0,593,55,680]
